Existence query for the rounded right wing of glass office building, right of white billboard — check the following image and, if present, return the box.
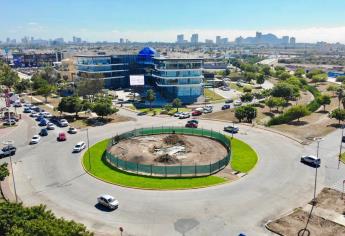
[152,58,204,104]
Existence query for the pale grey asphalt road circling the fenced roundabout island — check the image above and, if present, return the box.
[2,110,345,236]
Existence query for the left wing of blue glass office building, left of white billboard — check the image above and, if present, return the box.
[75,55,129,89]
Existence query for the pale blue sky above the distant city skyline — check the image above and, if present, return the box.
[0,0,345,43]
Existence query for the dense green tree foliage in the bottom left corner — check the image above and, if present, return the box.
[0,202,93,236]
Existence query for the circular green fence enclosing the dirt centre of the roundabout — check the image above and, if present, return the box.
[105,127,231,177]
